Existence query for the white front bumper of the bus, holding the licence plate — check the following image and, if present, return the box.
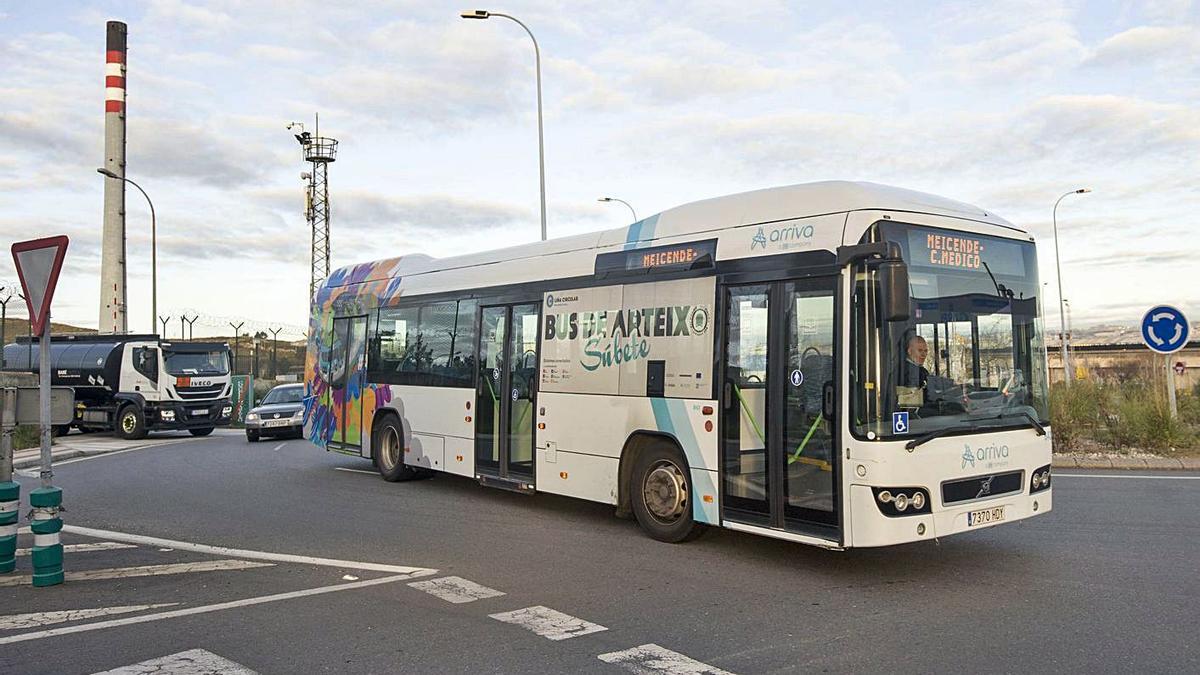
[847,485,1054,548]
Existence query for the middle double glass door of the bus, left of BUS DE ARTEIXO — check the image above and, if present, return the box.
[475,303,541,486]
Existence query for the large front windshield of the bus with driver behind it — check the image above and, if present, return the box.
[851,222,1049,440]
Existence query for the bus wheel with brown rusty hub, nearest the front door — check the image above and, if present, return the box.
[629,442,703,544]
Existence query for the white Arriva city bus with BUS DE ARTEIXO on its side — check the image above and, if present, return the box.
[305,183,1051,549]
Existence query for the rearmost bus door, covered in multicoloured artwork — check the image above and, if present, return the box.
[329,316,367,448]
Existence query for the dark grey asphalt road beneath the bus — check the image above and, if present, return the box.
[0,427,1200,673]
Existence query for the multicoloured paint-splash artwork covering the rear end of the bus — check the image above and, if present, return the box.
[305,258,402,447]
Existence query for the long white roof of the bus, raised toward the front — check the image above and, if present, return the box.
[325,180,1024,287]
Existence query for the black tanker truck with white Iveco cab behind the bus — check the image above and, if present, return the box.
[4,334,233,438]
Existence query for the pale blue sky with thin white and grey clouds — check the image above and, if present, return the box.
[0,0,1200,335]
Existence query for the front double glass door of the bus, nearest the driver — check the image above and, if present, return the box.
[721,277,839,539]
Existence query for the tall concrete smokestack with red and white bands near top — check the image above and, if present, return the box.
[98,22,127,333]
